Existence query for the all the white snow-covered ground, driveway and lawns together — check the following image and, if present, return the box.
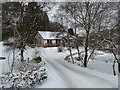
[0,42,118,88]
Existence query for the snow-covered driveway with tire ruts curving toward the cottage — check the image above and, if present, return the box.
[38,49,118,88]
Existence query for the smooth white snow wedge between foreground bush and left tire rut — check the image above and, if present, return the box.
[36,59,67,88]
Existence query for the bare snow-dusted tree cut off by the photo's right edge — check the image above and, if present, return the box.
[98,3,120,75]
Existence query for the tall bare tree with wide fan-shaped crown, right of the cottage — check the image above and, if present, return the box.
[61,2,109,67]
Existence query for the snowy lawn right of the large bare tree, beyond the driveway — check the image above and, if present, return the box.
[88,52,118,75]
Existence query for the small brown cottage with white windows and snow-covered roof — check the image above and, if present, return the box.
[34,31,62,47]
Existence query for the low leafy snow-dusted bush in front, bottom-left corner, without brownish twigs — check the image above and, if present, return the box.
[1,69,47,90]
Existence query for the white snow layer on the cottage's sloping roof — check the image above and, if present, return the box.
[38,31,59,39]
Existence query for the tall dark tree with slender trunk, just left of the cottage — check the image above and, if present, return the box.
[15,2,50,61]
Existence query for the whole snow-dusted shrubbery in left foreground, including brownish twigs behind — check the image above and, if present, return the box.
[1,61,47,88]
